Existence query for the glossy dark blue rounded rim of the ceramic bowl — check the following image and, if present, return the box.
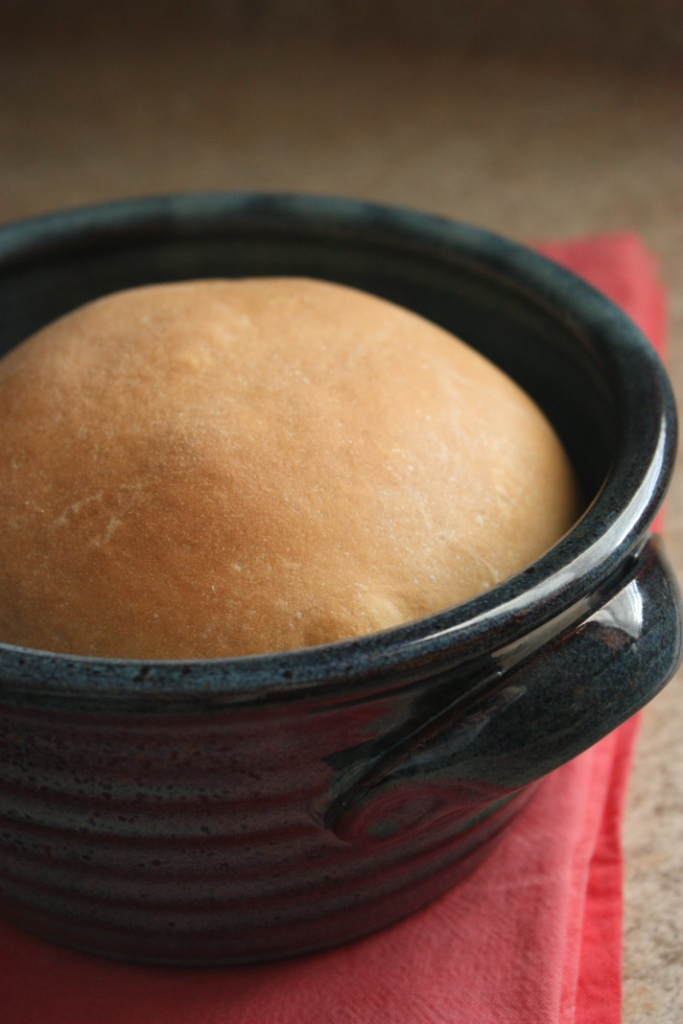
[0,193,677,703]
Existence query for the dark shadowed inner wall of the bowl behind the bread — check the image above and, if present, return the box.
[0,212,615,501]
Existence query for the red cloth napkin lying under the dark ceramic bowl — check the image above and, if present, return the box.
[0,234,665,1024]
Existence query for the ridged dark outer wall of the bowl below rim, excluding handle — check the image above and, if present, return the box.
[0,692,532,964]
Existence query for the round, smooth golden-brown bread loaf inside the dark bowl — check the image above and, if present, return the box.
[0,279,578,658]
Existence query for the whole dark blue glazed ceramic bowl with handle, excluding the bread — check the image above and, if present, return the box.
[0,195,681,965]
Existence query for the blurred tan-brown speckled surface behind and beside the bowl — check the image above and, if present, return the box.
[0,0,683,1024]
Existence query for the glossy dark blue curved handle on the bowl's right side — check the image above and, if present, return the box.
[324,538,681,844]
